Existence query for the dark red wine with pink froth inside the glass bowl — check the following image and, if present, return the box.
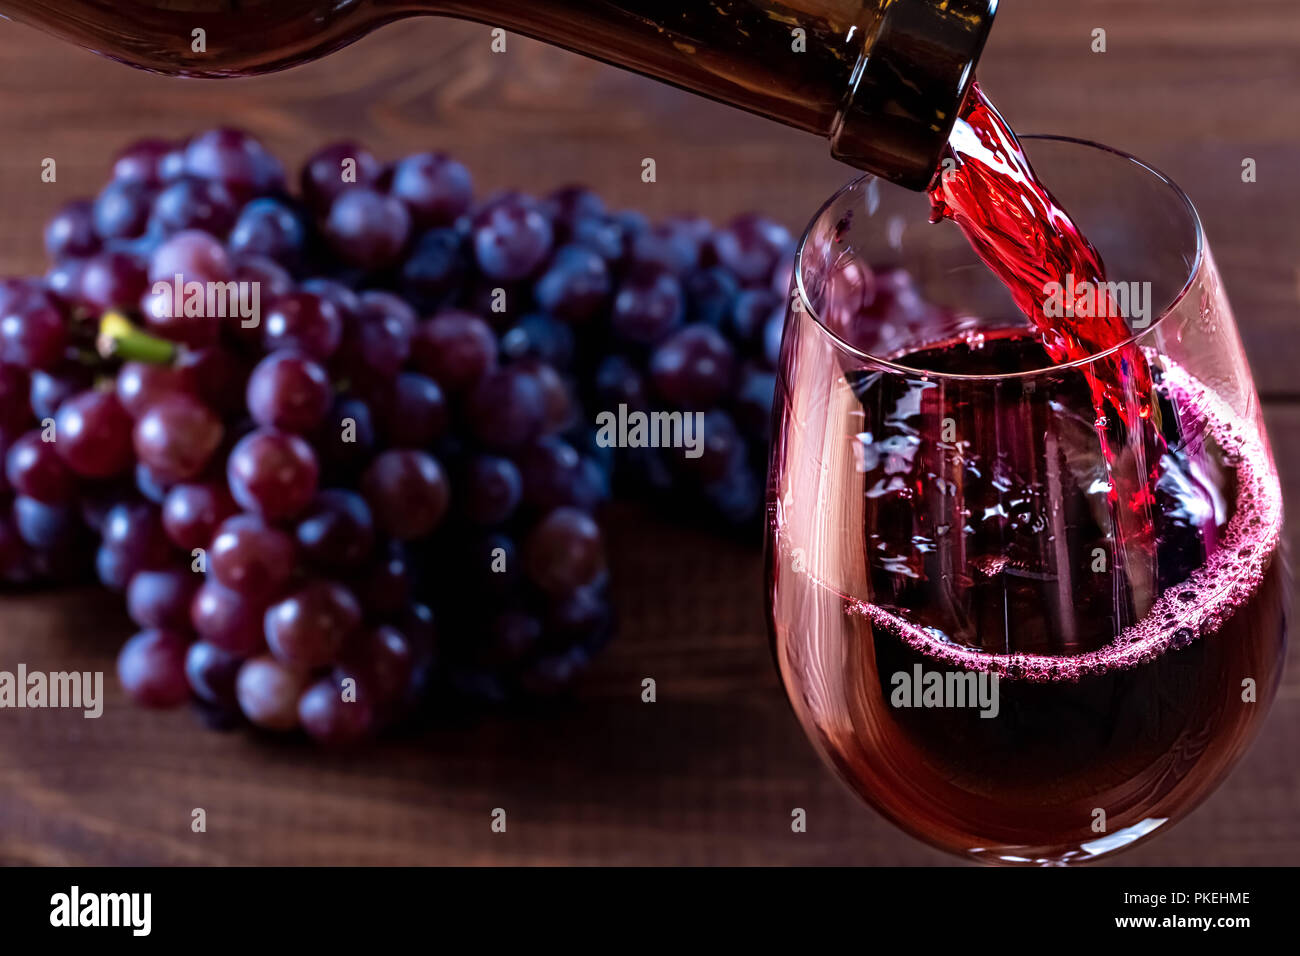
[770,332,1286,862]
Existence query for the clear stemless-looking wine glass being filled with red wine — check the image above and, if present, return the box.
[767,137,1287,865]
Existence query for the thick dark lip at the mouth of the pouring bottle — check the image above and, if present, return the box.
[831,0,997,190]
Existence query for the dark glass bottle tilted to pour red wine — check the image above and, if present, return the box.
[0,0,997,189]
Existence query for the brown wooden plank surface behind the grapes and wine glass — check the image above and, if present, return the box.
[0,0,1300,865]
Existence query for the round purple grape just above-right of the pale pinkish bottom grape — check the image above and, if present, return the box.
[265,581,361,670]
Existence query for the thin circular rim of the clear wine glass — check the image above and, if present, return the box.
[793,134,1206,381]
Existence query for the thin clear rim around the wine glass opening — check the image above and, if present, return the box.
[794,133,1205,381]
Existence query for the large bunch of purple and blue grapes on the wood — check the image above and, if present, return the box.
[0,129,792,744]
